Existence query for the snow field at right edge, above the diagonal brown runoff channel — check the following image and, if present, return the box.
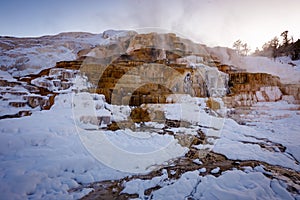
[213,101,300,171]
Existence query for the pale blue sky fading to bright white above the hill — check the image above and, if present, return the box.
[0,0,300,51]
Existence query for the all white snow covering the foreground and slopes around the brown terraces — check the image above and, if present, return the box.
[0,31,300,199]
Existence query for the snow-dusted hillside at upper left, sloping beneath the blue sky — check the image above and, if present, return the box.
[0,30,133,76]
